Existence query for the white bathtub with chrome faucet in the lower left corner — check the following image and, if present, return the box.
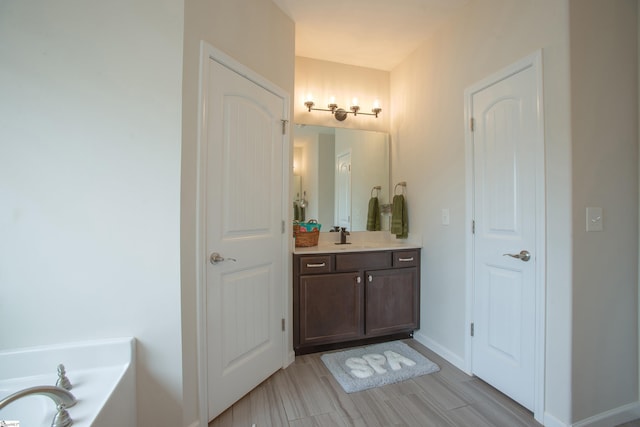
[0,338,137,427]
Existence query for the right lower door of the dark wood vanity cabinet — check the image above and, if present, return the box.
[365,267,419,336]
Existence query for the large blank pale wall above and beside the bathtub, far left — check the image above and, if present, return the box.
[0,0,184,427]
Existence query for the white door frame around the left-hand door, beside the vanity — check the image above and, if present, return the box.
[195,40,293,427]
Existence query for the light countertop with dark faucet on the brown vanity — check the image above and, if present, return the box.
[293,231,422,254]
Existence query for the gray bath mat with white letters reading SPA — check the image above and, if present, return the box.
[320,341,440,393]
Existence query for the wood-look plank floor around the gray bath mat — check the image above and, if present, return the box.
[209,340,541,427]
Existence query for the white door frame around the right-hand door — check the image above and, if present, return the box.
[464,49,546,423]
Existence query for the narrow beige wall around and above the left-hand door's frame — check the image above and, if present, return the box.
[180,0,294,425]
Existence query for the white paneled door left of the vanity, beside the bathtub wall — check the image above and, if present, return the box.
[203,53,287,420]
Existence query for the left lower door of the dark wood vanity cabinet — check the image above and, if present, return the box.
[300,272,364,345]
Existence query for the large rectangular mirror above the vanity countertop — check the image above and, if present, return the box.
[291,125,391,232]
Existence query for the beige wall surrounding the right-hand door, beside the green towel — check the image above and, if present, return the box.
[391,0,571,422]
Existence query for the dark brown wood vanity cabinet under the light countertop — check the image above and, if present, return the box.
[293,249,420,354]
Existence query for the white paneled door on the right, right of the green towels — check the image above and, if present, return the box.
[468,56,541,410]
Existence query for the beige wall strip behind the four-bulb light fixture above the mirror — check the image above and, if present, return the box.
[291,57,390,132]
